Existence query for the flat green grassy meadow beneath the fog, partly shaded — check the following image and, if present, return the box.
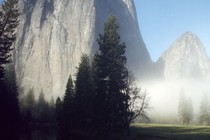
[131,124,210,140]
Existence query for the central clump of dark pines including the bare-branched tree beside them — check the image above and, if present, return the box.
[56,16,149,139]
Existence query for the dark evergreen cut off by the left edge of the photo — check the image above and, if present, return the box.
[0,0,19,139]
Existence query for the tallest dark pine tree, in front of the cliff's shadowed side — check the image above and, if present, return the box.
[95,16,128,135]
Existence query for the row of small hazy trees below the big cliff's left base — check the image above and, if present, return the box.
[19,89,55,124]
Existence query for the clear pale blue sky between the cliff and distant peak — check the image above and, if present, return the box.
[134,0,210,61]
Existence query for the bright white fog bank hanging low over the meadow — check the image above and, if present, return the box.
[138,80,210,123]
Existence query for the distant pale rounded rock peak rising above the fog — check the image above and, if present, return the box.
[161,32,210,80]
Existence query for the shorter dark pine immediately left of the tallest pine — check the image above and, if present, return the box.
[75,54,95,128]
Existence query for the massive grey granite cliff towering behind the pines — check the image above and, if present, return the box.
[14,0,151,98]
